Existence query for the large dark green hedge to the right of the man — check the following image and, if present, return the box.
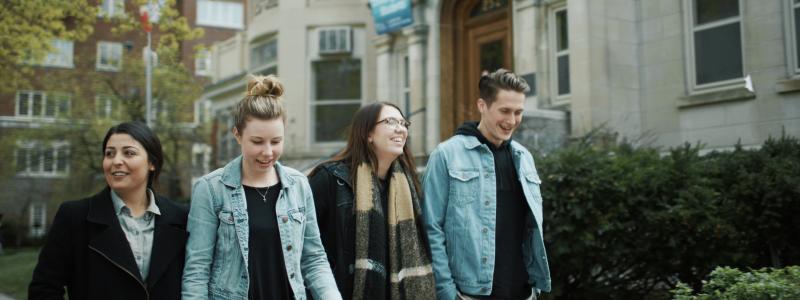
[537,137,800,299]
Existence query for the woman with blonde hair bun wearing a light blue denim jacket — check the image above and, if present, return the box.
[182,75,341,299]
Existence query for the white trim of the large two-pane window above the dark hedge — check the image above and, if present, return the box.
[683,0,747,95]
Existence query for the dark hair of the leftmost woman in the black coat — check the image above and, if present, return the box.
[101,122,164,187]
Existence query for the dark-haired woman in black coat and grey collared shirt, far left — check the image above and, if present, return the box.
[28,122,188,299]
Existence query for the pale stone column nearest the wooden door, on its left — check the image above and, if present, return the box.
[403,24,428,155]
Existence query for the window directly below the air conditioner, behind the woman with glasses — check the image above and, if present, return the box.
[311,57,362,142]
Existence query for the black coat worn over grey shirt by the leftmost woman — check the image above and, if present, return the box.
[28,188,189,299]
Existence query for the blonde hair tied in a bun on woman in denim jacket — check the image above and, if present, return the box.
[233,75,286,133]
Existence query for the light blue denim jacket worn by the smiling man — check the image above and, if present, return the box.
[422,135,550,300]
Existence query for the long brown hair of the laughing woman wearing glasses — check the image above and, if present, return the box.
[311,101,422,195]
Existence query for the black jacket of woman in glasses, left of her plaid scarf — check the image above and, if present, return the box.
[308,161,356,299]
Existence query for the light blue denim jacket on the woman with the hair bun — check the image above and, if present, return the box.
[182,156,341,299]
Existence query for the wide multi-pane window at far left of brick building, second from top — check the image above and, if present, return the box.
[16,91,71,119]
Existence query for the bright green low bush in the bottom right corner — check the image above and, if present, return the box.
[673,266,800,300]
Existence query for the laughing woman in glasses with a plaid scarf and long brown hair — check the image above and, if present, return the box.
[309,102,436,299]
